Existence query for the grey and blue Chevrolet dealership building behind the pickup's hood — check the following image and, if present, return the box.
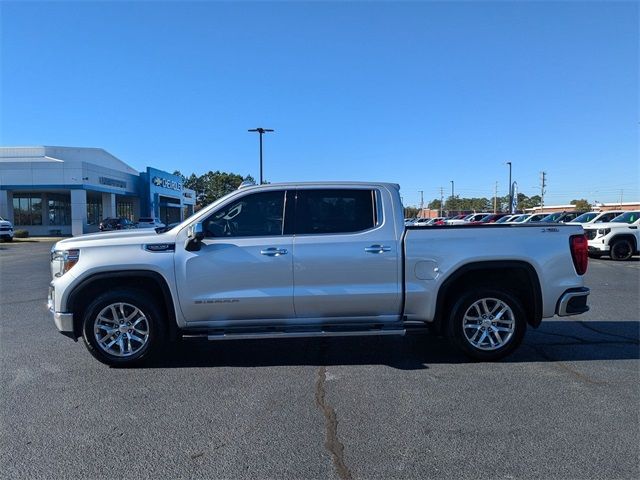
[0,146,196,235]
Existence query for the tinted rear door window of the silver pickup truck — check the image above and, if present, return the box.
[295,189,376,234]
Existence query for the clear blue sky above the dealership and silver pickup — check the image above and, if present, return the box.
[0,1,640,204]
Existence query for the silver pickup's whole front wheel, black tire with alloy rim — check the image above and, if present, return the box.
[82,290,167,366]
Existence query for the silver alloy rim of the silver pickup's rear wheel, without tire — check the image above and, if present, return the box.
[462,298,515,350]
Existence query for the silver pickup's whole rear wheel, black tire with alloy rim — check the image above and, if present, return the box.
[447,288,527,361]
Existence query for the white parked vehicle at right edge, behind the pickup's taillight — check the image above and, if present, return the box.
[584,211,640,260]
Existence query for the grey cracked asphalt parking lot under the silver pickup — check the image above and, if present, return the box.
[0,242,640,479]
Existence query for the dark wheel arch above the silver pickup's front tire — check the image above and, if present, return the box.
[66,270,178,338]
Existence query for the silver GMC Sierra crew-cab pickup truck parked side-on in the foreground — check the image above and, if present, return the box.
[48,182,589,365]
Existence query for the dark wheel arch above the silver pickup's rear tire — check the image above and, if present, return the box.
[434,260,542,333]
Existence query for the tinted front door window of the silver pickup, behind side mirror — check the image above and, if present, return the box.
[203,191,284,237]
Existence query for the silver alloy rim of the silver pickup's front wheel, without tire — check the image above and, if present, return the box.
[93,302,149,357]
